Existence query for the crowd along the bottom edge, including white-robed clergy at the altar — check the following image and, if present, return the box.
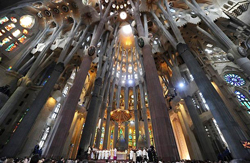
[0,146,246,163]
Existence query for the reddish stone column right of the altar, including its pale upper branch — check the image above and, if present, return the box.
[130,0,179,161]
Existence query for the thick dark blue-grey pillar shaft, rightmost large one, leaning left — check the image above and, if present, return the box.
[177,43,250,159]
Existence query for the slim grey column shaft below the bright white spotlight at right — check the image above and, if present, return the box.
[184,96,217,161]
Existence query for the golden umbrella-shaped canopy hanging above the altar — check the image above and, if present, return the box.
[110,108,132,126]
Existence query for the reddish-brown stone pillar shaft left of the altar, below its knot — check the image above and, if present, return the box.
[47,55,92,158]
